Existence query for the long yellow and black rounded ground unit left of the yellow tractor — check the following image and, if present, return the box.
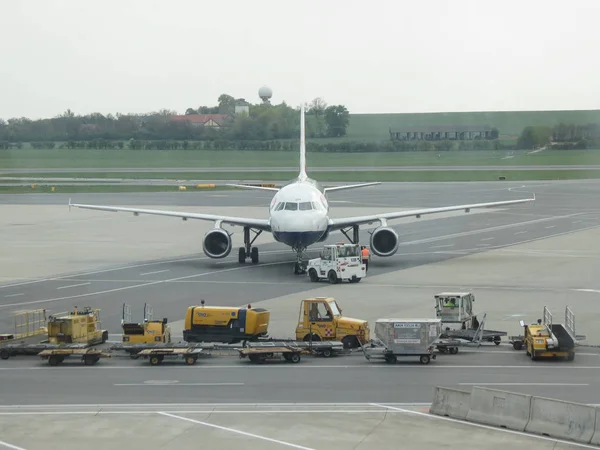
[183,300,271,344]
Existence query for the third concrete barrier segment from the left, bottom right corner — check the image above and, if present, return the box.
[525,397,596,444]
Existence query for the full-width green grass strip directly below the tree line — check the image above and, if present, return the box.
[0,149,600,174]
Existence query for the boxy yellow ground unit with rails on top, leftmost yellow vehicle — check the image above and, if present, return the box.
[48,306,108,345]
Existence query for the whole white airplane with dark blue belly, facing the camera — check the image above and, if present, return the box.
[69,106,535,274]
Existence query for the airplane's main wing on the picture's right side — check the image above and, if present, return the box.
[329,194,535,231]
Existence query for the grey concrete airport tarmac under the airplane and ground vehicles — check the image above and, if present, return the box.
[0,181,600,450]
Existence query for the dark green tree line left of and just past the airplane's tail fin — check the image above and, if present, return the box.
[0,94,350,143]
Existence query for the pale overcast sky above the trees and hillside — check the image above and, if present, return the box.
[0,0,600,119]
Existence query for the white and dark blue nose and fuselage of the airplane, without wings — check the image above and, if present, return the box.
[269,178,329,251]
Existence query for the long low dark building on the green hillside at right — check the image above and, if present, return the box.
[390,125,493,141]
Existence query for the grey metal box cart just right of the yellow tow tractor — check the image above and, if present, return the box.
[362,319,442,364]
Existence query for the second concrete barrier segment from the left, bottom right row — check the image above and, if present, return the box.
[467,387,532,431]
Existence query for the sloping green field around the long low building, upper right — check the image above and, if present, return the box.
[347,110,600,141]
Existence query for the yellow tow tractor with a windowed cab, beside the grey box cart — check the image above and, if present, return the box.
[296,297,371,348]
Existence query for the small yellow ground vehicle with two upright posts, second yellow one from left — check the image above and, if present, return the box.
[121,304,171,344]
